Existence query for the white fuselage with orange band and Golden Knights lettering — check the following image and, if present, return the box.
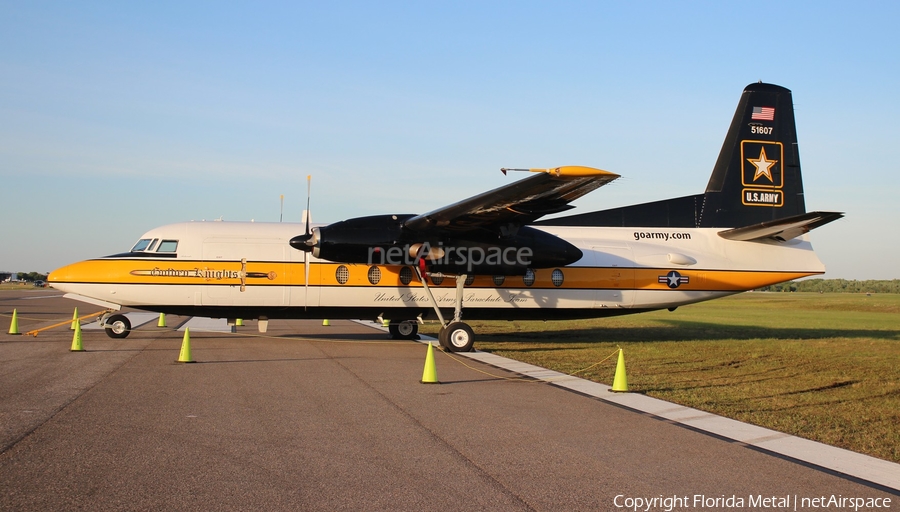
[49,222,825,319]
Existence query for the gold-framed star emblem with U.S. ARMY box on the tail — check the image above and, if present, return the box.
[741,140,784,207]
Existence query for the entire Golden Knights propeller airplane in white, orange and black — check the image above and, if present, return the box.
[49,82,844,352]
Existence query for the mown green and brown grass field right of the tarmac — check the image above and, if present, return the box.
[423,293,900,462]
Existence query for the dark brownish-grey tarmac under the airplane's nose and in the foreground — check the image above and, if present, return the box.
[0,290,900,510]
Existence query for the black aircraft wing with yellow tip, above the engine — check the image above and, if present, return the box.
[404,166,619,232]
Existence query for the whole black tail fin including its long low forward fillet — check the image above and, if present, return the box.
[535,83,806,228]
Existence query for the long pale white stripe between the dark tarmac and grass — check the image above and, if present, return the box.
[357,320,900,491]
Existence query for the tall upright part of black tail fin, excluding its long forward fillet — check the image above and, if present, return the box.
[697,83,806,227]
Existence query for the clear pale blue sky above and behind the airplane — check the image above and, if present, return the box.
[0,1,900,279]
